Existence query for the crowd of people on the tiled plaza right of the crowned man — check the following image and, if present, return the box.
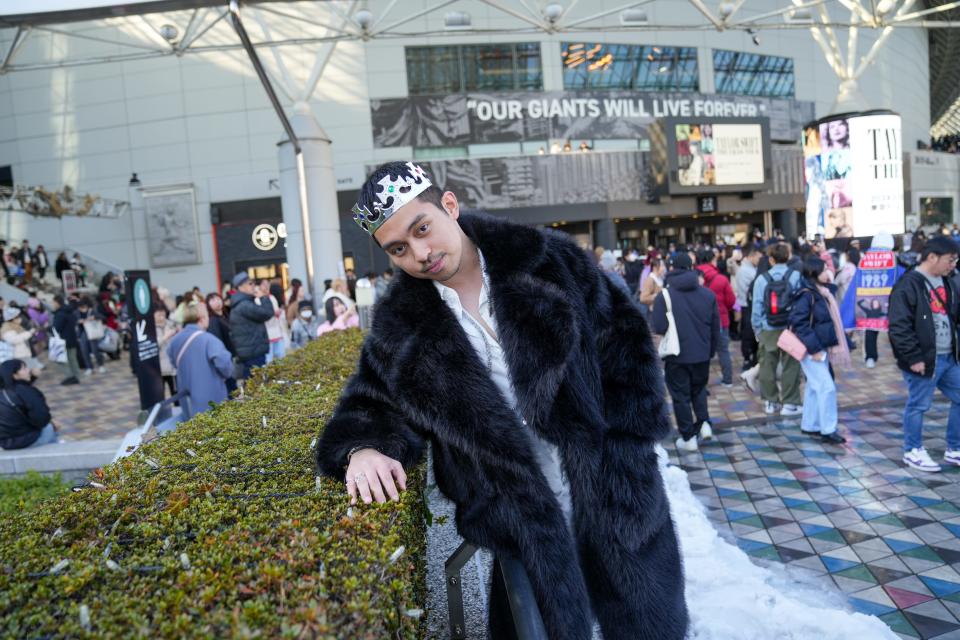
[596,225,960,471]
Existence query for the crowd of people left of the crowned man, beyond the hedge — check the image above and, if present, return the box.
[0,262,393,449]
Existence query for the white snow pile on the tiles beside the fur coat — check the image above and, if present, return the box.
[658,448,897,640]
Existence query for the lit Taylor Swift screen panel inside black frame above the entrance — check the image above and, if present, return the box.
[675,123,764,187]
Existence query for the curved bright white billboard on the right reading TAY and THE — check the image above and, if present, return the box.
[803,111,904,238]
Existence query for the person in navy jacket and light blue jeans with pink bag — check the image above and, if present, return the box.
[789,255,850,444]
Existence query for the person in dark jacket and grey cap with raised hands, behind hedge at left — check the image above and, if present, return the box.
[230,272,273,380]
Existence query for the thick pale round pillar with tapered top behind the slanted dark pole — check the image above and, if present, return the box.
[278,102,343,295]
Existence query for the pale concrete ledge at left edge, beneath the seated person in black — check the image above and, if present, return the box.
[0,438,123,474]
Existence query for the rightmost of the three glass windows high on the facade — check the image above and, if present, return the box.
[713,49,794,98]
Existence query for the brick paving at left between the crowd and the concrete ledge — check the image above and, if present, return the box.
[36,352,140,440]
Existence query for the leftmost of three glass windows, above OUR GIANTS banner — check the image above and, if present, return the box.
[406,42,543,95]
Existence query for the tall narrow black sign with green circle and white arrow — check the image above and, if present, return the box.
[124,271,163,410]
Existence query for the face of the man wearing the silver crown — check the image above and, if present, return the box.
[374,191,464,282]
